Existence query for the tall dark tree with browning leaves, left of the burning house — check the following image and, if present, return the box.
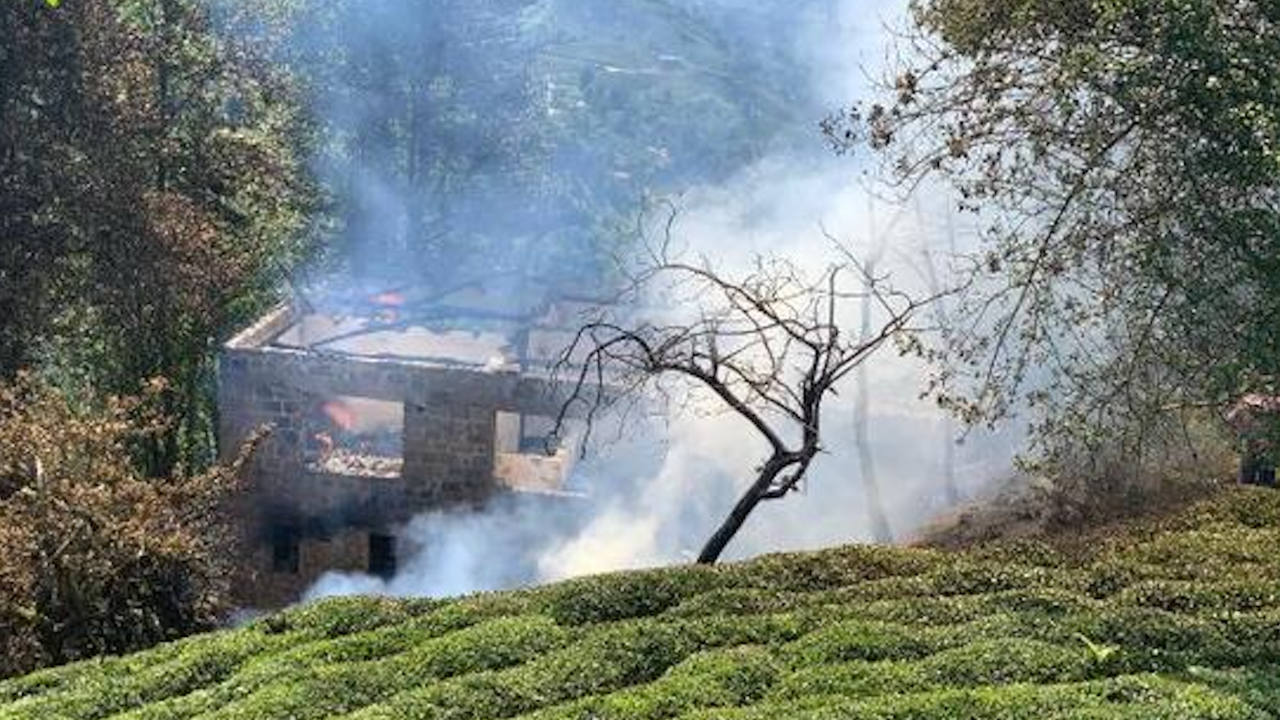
[0,0,311,475]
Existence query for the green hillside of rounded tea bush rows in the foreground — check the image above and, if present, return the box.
[0,489,1280,720]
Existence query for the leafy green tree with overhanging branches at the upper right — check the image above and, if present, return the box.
[827,0,1280,471]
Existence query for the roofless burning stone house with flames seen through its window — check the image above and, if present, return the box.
[219,280,582,607]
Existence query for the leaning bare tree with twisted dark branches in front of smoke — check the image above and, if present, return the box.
[556,233,928,564]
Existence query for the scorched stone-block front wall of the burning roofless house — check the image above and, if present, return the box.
[219,333,568,607]
